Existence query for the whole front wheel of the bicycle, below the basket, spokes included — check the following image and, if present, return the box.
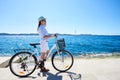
[52,50,74,72]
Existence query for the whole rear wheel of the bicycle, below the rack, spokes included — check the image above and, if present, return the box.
[9,52,37,77]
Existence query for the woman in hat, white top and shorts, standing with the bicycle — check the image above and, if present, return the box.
[37,16,55,72]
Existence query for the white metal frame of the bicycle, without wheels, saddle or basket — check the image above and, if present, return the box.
[33,38,60,60]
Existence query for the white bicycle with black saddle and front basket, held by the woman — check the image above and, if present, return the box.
[9,35,74,77]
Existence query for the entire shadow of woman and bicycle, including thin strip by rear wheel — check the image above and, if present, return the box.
[19,72,82,80]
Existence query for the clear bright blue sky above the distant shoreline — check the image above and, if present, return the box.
[0,0,120,35]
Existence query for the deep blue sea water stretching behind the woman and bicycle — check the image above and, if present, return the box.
[0,35,120,56]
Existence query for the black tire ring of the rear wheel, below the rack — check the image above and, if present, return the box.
[9,52,37,77]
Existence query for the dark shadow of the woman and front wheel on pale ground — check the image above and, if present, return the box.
[38,72,82,80]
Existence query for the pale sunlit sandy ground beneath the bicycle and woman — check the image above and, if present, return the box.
[0,57,120,80]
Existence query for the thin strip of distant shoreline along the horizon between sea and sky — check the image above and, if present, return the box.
[0,33,120,36]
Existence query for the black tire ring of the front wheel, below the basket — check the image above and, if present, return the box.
[51,50,74,72]
